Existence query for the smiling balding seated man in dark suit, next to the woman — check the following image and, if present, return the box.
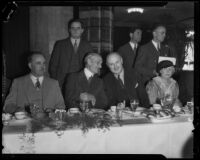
[103,52,149,108]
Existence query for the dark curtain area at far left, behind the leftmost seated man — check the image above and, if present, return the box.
[2,7,29,80]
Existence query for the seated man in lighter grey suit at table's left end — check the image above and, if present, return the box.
[3,52,65,114]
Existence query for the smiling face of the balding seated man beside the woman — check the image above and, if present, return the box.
[107,54,123,75]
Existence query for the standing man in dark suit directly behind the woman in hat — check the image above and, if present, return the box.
[135,25,171,85]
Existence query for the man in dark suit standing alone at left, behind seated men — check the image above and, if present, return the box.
[49,19,92,88]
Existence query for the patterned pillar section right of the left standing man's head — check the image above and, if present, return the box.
[79,6,113,54]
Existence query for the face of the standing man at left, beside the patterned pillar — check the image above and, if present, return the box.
[69,22,83,39]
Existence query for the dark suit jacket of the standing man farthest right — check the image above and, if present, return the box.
[135,41,171,83]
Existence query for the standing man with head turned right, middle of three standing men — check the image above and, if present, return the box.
[118,27,142,68]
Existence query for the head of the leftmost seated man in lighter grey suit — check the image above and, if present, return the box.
[28,54,46,77]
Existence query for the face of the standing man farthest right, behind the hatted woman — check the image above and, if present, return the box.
[153,26,166,42]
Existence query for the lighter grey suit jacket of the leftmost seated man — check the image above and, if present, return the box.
[4,74,65,113]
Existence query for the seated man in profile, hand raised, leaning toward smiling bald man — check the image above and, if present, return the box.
[65,53,107,109]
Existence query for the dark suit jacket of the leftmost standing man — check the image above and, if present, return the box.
[49,38,92,87]
